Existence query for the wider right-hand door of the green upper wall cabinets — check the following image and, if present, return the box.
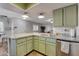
[64,5,78,27]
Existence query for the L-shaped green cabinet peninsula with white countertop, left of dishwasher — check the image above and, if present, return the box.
[9,33,56,56]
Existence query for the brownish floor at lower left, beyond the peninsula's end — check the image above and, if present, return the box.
[0,42,8,56]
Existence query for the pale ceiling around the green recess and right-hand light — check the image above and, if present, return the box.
[0,3,72,24]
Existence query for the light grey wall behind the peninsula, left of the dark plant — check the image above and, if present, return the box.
[12,18,41,34]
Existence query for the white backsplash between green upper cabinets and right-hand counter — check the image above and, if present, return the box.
[53,27,74,37]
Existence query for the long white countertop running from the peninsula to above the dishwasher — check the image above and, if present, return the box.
[10,33,79,41]
